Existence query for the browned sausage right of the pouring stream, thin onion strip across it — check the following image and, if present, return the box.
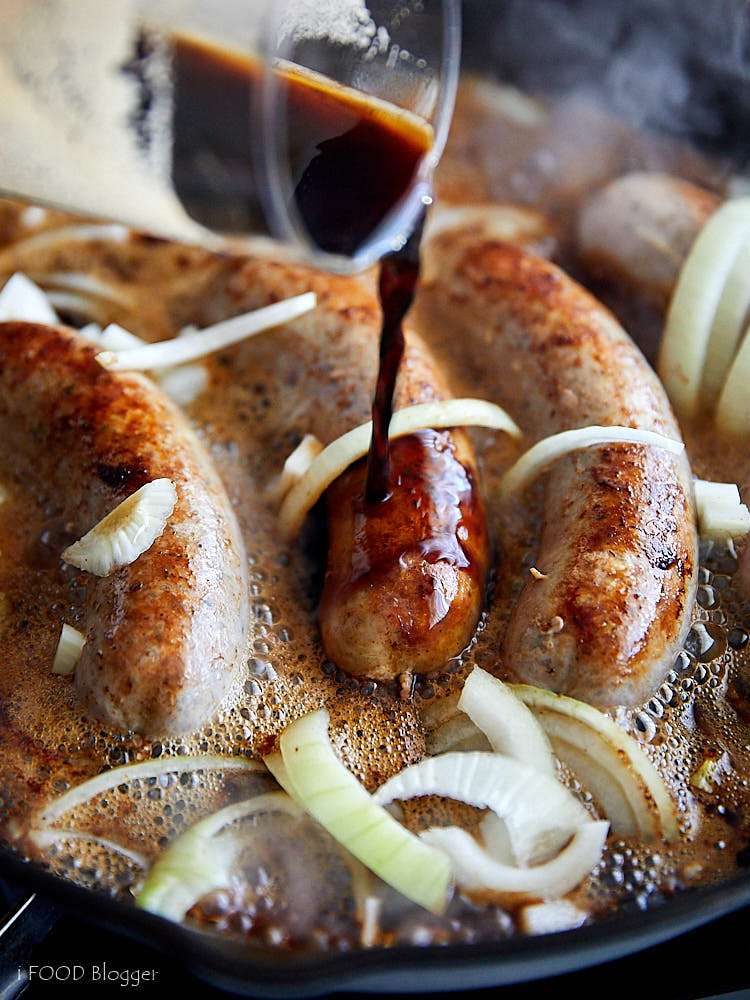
[418,234,697,705]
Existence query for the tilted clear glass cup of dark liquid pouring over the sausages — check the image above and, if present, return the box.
[0,0,460,271]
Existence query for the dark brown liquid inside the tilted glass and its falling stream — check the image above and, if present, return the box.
[168,36,432,503]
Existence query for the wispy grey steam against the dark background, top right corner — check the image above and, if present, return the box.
[464,0,750,158]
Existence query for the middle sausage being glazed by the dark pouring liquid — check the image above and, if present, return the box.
[200,258,490,679]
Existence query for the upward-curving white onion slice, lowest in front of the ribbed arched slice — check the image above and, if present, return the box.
[420,822,609,899]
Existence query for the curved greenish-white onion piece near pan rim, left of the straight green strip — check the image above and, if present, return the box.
[135,792,303,922]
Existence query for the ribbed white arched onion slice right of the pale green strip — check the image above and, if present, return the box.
[374,750,591,864]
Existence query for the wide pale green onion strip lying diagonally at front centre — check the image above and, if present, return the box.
[279,709,451,913]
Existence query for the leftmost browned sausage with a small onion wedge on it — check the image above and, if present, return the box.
[0,323,248,736]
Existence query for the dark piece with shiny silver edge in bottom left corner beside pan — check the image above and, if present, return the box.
[0,893,59,1000]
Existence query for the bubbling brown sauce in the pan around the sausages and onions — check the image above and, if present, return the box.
[0,78,750,949]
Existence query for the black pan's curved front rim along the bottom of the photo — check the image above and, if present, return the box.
[0,847,750,998]
